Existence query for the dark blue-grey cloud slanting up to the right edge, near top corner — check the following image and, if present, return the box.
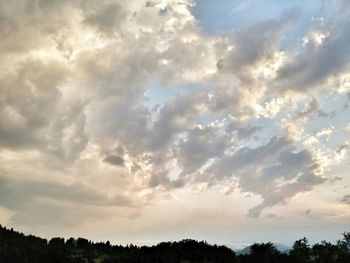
[277,4,350,92]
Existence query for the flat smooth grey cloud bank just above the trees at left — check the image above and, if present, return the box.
[0,177,139,227]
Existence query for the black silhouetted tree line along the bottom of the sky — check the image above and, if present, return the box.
[0,225,350,263]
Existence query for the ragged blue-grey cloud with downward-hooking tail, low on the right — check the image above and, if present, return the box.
[204,137,325,217]
